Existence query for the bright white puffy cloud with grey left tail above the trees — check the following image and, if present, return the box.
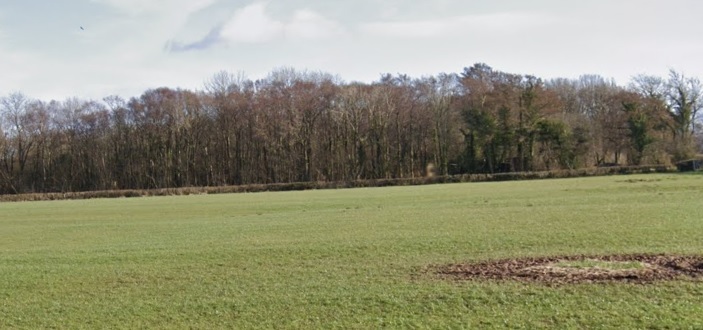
[165,2,344,52]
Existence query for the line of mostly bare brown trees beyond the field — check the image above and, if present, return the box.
[0,63,703,194]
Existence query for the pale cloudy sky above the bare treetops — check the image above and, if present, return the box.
[0,0,703,101]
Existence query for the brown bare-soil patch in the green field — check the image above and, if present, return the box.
[432,255,703,284]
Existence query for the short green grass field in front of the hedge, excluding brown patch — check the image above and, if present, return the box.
[0,174,703,329]
